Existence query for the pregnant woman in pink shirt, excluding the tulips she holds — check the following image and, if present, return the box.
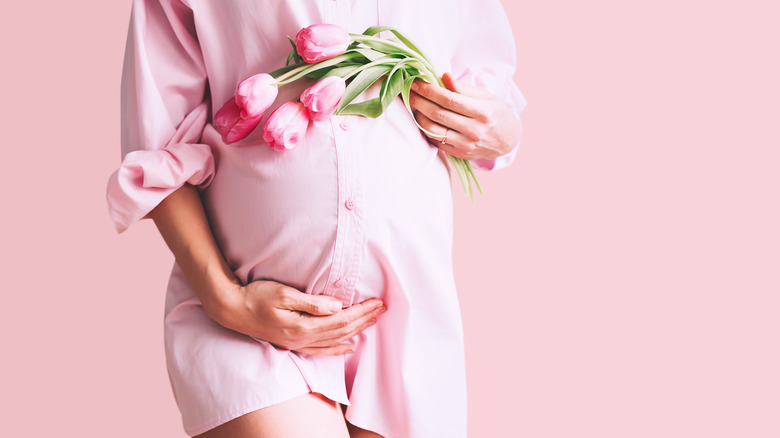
[107,0,525,438]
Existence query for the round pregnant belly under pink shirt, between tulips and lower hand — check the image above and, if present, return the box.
[203,102,452,305]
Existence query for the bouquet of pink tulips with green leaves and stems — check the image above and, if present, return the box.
[214,24,482,199]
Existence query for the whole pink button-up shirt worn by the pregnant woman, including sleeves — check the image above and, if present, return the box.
[107,0,525,438]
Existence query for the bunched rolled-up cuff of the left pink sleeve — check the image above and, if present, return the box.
[106,143,214,233]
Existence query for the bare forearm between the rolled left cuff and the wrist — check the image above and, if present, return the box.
[149,184,240,323]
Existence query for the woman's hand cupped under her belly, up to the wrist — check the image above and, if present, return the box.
[213,281,387,356]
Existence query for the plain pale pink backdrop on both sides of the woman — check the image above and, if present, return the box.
[0,0,780,438]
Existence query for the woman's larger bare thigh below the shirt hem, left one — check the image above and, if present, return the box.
[197,393,350,438]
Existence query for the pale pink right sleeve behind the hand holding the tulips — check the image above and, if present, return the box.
[452,0,526,171]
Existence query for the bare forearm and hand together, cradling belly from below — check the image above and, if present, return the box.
[149,184,385,356]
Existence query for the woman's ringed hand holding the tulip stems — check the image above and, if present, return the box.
[409,73,523,160]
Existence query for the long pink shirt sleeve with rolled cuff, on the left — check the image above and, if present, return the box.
[106,0,214,232]
